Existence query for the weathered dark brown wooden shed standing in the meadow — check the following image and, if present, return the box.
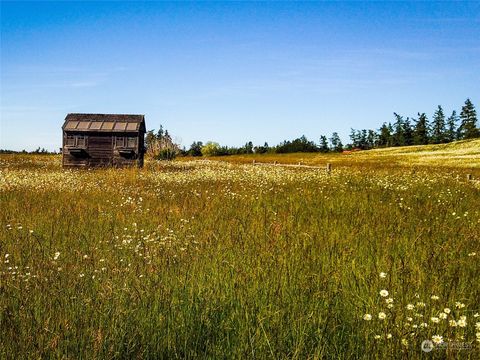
[62,114,145,167]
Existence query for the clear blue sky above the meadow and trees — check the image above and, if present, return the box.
[0,1,480,150]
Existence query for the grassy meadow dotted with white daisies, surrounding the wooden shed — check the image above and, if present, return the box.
[0,141,480,359]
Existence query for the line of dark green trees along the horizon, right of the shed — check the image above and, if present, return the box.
[146,99,480,159]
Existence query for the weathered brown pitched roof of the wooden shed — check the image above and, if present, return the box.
[62,114,145,132]
